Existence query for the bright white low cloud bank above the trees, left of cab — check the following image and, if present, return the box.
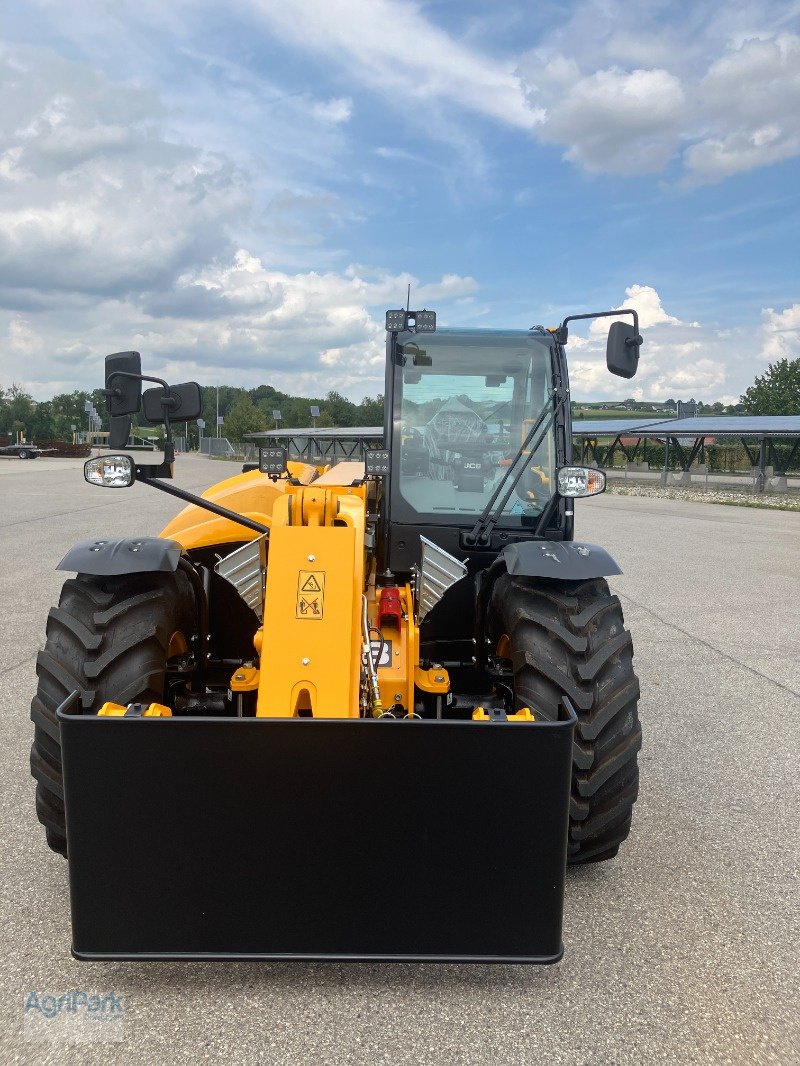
[0,249,477,399]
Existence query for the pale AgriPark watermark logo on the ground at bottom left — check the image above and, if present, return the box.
[22,991,125,1044]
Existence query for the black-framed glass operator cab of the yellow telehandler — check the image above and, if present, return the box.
[385,326,569,572]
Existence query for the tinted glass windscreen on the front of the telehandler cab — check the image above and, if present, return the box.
[395,329,556,524]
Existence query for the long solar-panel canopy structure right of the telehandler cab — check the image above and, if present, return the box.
[573,415,800,491]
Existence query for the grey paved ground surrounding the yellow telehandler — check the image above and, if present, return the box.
[0,458,800,1066]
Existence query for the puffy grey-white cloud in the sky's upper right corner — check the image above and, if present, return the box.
[518,8,800,184]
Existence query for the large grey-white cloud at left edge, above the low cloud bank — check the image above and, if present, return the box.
[0,49,249,295]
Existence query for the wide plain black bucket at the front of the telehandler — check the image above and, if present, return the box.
[59,702,575,963]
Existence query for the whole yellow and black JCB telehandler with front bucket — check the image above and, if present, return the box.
[31,309,641,963]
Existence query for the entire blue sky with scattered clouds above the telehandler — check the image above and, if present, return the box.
[0,0,800,401]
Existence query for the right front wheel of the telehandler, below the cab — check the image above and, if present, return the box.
[487,575,641,863]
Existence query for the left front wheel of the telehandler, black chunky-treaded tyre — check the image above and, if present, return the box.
[31,571,196,855]
